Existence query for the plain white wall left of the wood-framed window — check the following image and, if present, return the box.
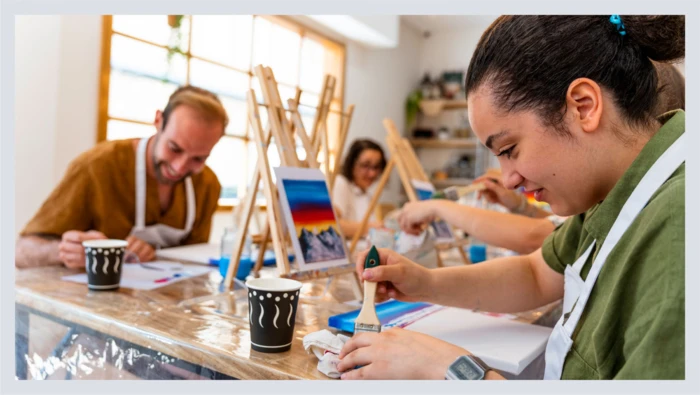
[15,16,102,237]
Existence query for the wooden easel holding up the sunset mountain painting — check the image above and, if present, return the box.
[224,66,361,298]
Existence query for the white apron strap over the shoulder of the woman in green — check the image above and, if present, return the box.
[564,133,687,337]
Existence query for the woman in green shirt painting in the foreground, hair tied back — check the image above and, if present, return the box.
[338,15,688,379]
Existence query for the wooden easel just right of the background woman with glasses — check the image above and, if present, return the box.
[350,118,471,266]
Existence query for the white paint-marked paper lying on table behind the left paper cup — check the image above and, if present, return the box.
[61,261,214,291]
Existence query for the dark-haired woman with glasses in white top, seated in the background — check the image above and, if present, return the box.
[333,139,386,237]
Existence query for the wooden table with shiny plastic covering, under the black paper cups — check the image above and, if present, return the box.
[15,267,558,380]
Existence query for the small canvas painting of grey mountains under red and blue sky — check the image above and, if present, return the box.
[281,179,345,263]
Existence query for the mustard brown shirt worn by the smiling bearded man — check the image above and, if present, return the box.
[20,139,221,244]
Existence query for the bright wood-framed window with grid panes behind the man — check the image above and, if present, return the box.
[98,15,345,206]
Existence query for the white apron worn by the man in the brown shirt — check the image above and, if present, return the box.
[131,137,196,249]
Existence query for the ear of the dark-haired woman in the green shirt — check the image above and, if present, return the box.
[566,78,603,133]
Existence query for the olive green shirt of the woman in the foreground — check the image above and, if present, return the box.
[542,110,685,380]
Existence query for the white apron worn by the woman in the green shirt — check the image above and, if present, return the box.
[544,134,687,380]
